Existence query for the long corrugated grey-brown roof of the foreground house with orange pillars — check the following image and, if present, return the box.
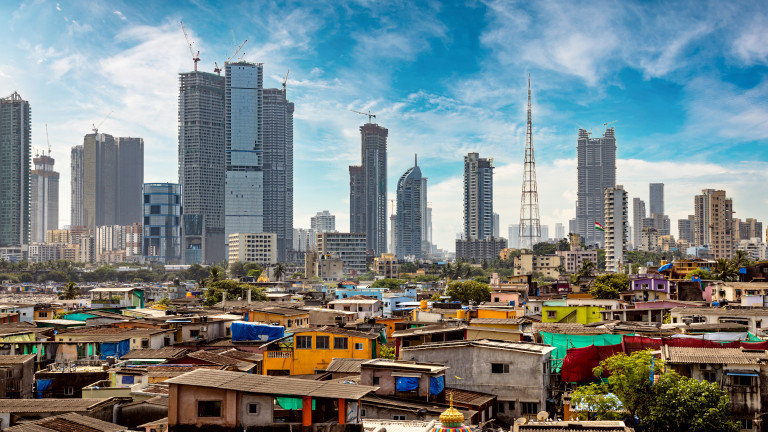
[166,369,378,399]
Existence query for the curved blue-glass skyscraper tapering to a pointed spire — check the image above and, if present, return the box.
[395,155,427,259]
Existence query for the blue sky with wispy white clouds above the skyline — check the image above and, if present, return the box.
[0,0,768,250]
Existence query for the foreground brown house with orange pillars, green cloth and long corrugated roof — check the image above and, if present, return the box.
[168,369,376,432]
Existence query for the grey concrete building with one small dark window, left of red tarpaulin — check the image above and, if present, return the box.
[402,340,555,423]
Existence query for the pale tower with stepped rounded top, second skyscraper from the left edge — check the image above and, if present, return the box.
[30,152,59,243]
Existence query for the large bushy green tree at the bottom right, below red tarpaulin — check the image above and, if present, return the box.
[571,350,738,432]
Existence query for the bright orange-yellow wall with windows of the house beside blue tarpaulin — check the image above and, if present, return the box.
[263,331,376,375]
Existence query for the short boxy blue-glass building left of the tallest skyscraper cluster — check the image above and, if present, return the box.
[142,183,181,264]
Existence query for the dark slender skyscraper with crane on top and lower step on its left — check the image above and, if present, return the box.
[349,120,389,255]
